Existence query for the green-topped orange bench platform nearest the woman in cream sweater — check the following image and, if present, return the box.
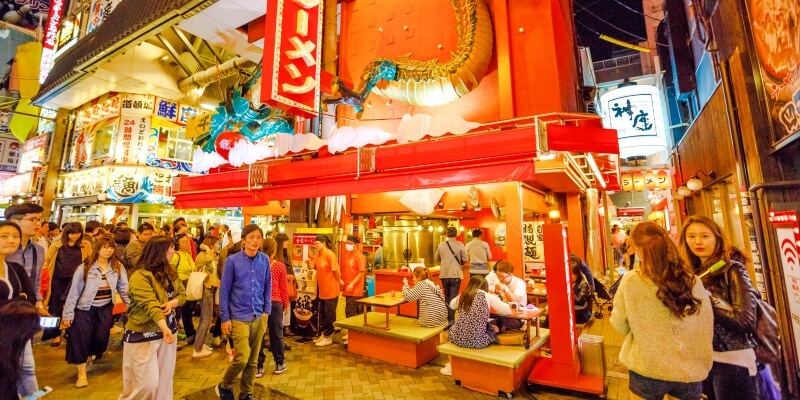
[439,328,550,398]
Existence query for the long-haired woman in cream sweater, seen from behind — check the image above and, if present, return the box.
[611,222,714,400]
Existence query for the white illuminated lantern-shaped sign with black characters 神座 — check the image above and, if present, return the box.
[600,85,667,159]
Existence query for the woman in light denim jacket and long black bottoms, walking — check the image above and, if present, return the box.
[61,236,131,387]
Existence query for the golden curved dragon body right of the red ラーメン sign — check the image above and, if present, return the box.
[323,0,494,118]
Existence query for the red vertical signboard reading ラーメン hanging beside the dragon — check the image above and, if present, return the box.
[261,0,322,118]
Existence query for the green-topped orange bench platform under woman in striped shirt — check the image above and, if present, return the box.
[334,312,443,368]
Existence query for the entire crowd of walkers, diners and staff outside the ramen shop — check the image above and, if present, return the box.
[0,203,780,400]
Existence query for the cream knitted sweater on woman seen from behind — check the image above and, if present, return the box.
[611,270,714,382]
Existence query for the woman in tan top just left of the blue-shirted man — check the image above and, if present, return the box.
[192,235,219,358]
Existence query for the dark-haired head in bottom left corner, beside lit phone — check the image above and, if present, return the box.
[0,298,39,400]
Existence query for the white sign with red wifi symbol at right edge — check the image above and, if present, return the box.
[769,211,800,364]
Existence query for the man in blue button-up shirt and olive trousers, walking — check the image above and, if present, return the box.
[216,225,272,400]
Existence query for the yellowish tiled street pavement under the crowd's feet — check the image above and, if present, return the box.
[34,310,628,400]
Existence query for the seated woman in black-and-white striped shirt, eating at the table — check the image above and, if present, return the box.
[403,267,447,328]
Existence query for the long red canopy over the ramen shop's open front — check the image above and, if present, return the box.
[173,113,619,208]
